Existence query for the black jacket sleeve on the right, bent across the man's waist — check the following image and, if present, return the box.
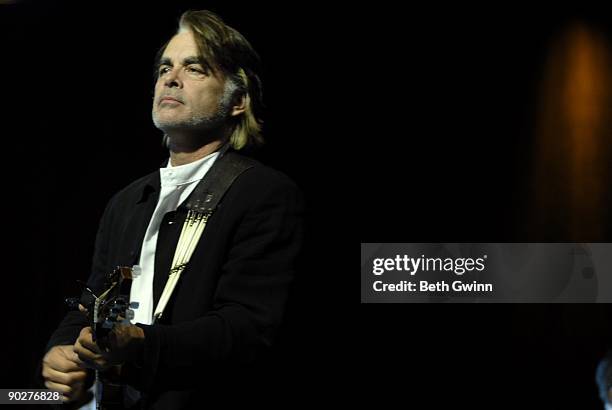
[139,175,303,391]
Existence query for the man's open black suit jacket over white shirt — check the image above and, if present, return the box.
[47,153,303,408]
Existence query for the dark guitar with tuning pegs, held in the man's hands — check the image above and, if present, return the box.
[66,266,140,410]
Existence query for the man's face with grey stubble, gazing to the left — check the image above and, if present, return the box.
[153,31,231,132]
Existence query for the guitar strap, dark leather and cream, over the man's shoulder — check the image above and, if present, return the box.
[153,151,257,323]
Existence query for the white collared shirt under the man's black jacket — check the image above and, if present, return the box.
[130,147,227,325]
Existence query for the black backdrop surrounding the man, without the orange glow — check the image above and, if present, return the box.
[0,1,612,409]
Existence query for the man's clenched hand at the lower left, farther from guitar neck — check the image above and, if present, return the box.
[42,345,91,403]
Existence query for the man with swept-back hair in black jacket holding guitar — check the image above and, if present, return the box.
[42,11,302,408]
